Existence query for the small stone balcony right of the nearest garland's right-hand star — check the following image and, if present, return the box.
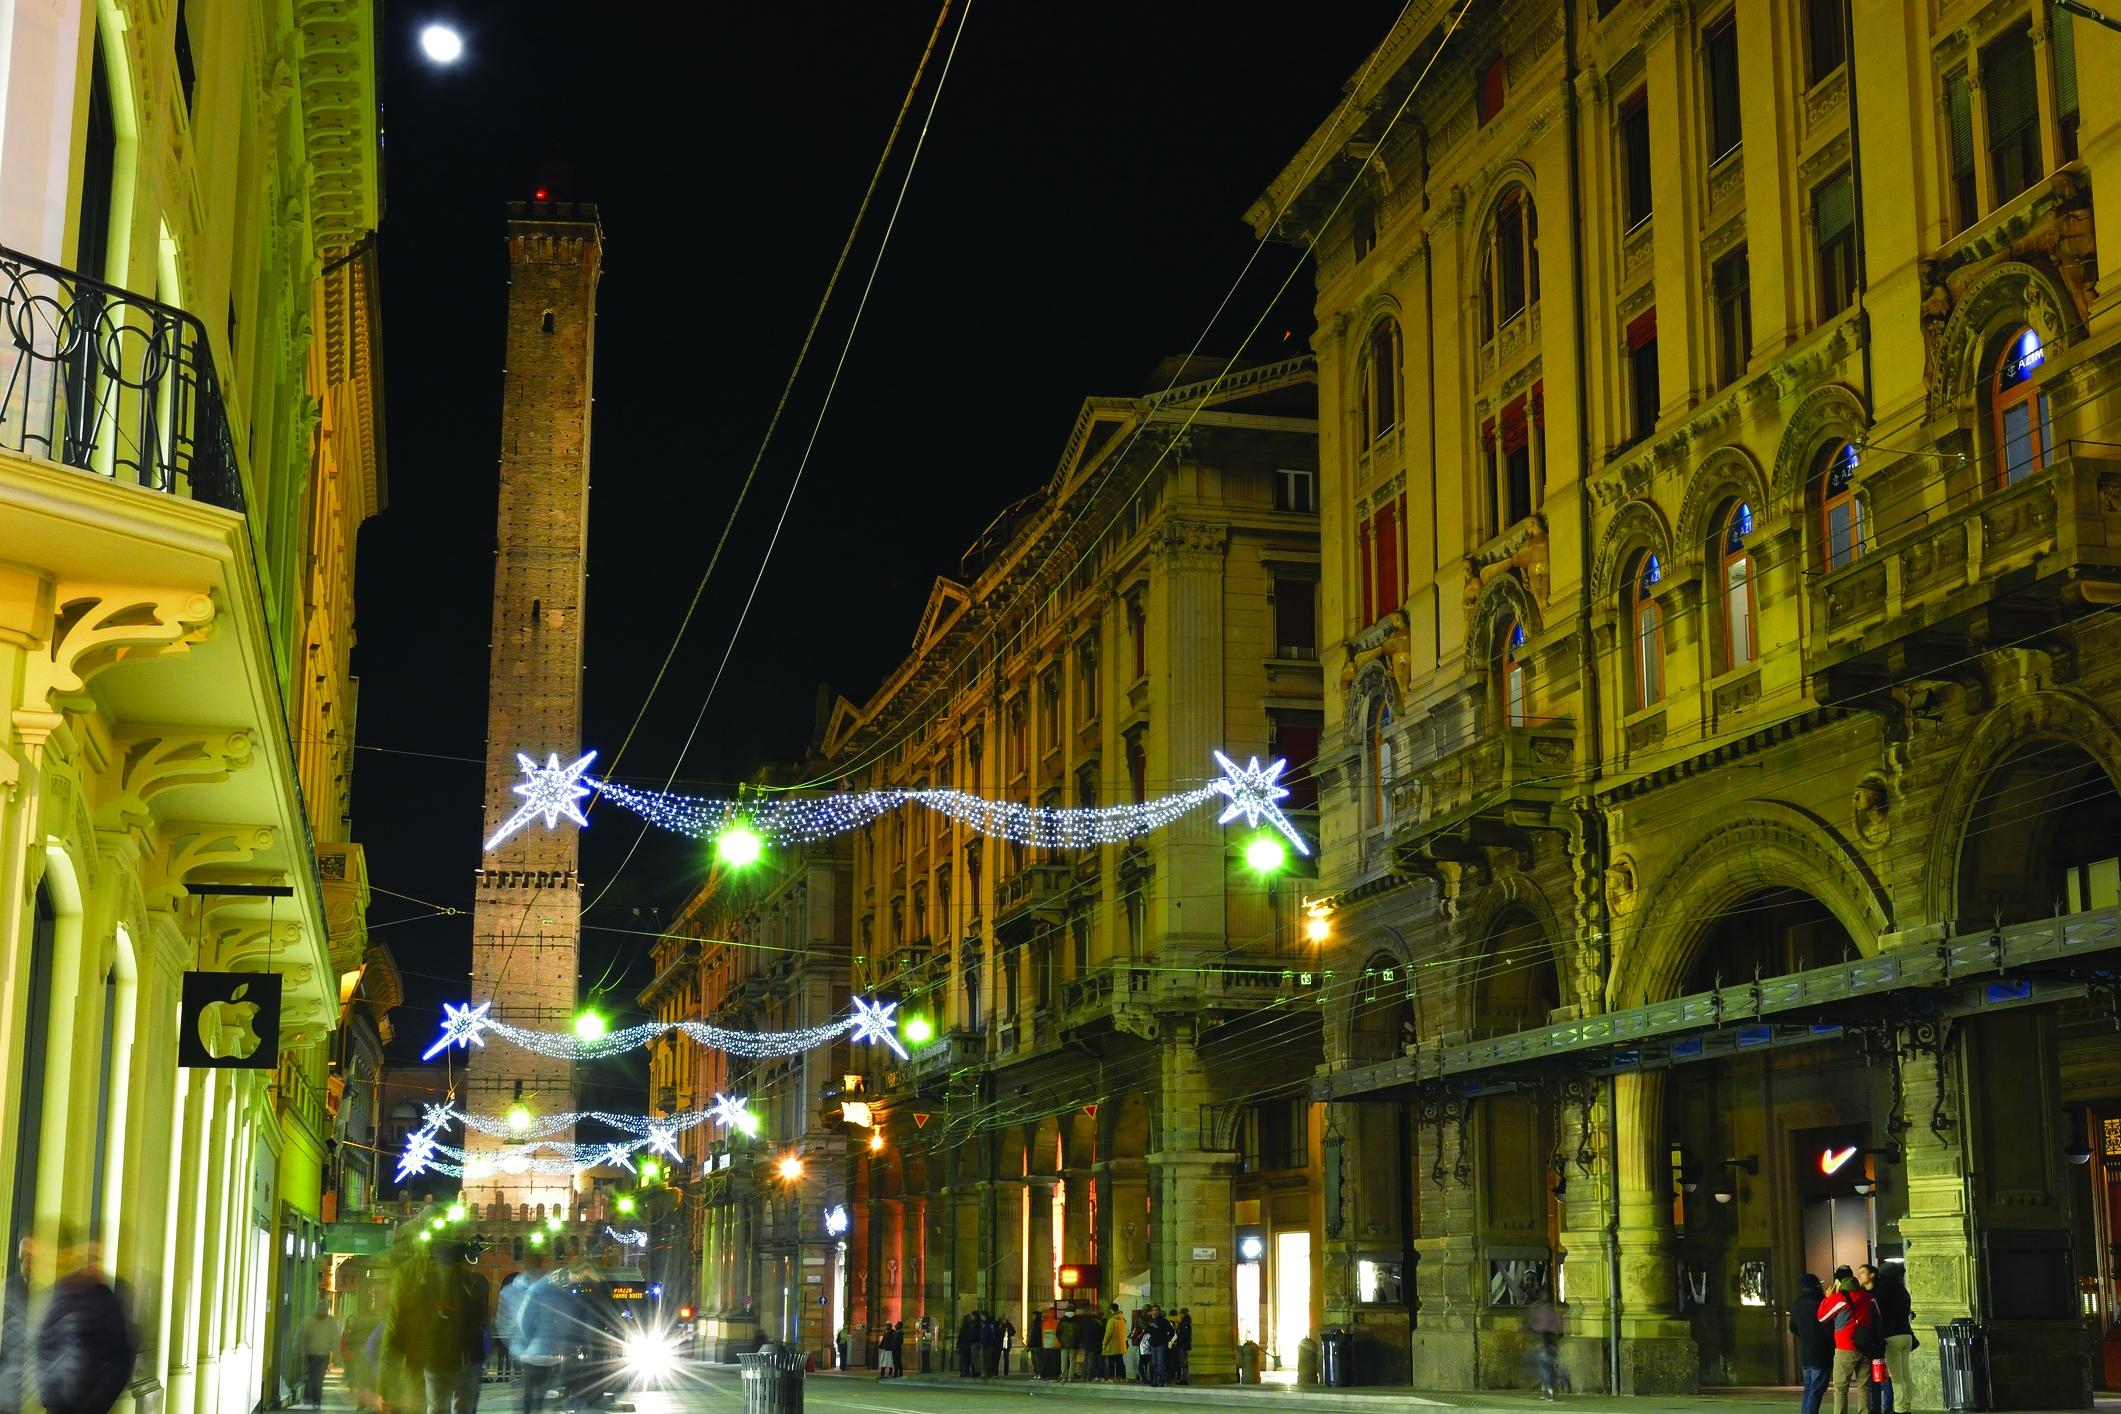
[1391,721,1576,873]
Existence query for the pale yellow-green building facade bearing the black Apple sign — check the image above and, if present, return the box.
[0,0,386,1414]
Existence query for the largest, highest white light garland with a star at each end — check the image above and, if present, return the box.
[486,750,1311,854]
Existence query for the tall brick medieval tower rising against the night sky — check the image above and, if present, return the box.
[464,201,602,1204]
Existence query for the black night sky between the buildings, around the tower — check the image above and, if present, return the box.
[354,0,1398,1102]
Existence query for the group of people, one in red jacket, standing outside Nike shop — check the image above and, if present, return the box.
[1790,1263,1920,1414]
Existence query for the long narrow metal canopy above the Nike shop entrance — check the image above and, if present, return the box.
[1311,907,2121,1100]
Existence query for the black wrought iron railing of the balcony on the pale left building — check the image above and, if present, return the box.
[0,248,244,511]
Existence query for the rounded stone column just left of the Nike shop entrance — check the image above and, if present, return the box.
[1612,1073,1701,1395]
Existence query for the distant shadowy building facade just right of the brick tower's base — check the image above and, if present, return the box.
[641,818,863,1369]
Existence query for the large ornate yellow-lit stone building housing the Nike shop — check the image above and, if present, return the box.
[1249,0,2121,1408]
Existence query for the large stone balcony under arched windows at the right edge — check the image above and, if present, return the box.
[1811,441,2121,702]
